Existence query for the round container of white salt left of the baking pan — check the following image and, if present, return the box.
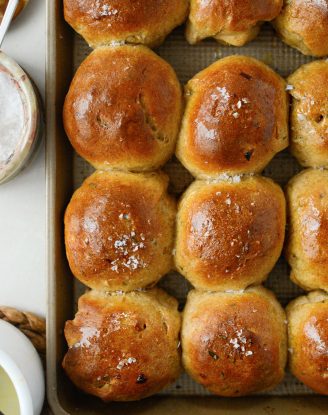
[0,51,43,184]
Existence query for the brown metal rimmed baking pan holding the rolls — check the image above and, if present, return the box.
[46,0,328,415]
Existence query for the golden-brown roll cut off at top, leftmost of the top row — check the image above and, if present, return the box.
[64,0,189,47]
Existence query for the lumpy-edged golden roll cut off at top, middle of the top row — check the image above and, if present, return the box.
[187,0,283,46]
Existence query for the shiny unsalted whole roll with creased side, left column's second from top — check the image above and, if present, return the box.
[64,46,182,171]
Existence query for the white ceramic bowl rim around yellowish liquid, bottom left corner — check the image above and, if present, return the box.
[0,320,45,415]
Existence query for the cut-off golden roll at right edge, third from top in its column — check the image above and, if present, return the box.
[286,170,328,291]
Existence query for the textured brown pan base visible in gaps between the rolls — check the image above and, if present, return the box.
[74,24,313,396]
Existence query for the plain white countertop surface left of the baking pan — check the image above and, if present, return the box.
[0,0,47,316]
